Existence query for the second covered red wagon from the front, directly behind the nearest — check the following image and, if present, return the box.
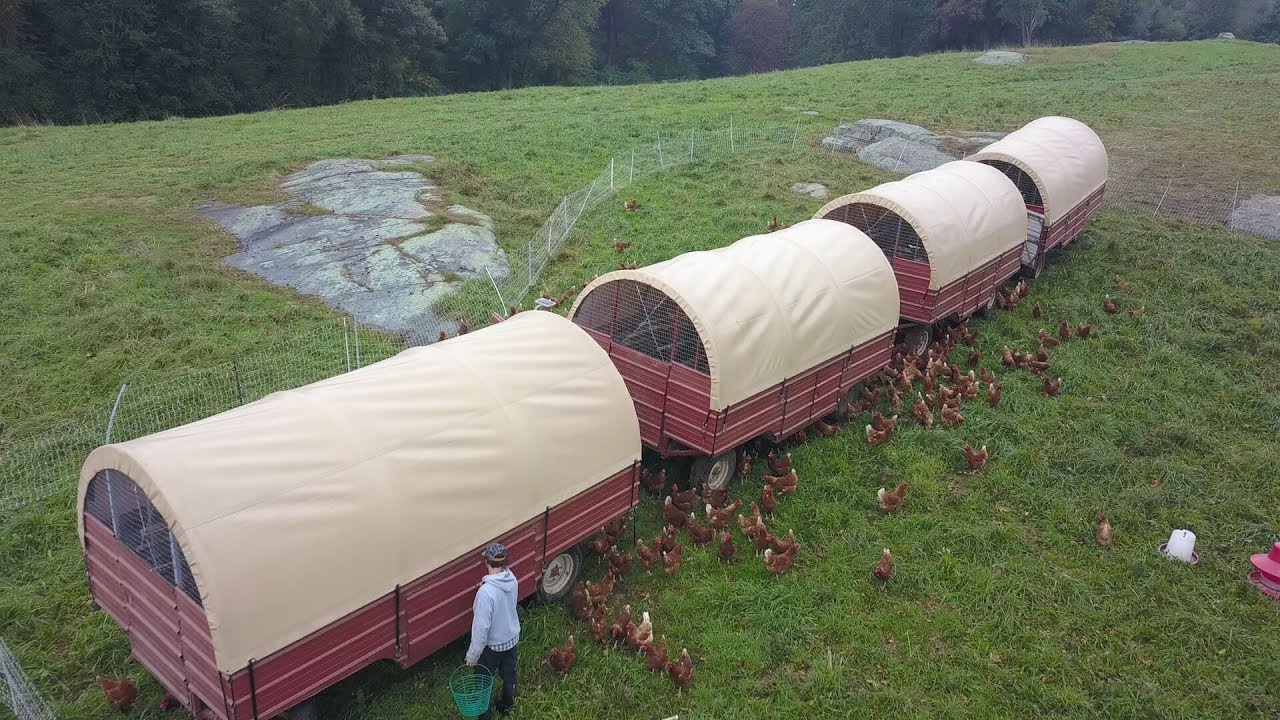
[570,219,901,487]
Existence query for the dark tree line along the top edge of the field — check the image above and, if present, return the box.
[0,0,1280,123]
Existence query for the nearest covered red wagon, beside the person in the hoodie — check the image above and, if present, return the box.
[79,313,640,720]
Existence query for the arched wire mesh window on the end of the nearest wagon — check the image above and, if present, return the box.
[84,470,200,603]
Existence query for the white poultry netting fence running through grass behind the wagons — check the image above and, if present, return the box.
[0,124,1274,521]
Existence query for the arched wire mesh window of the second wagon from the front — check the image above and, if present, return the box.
[573,281,710,374]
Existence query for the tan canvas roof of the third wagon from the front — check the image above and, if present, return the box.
[814,160,1027,290]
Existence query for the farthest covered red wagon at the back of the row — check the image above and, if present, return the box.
[966,117,1110,277]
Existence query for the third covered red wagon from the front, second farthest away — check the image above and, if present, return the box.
[814,160,1027,354]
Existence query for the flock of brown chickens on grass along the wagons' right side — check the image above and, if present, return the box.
[549,271,1143,688]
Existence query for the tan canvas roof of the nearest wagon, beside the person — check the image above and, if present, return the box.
[79,311,640,673]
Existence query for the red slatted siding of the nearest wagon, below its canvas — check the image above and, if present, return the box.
[84,466,639,720]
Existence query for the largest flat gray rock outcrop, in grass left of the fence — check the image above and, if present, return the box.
[201,155,511,332]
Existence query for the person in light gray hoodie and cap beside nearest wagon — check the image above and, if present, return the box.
[467,542,520,720]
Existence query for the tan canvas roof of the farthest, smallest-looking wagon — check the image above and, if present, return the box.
[966,117,1110,223]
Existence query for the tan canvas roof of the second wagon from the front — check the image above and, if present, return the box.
[570,219,901,410]
